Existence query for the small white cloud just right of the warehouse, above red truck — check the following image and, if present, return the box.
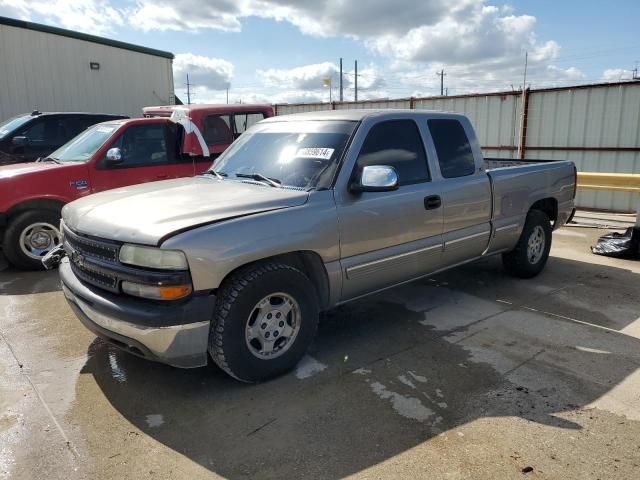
[173,53,233,90]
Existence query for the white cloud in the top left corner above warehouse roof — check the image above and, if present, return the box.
[0,0,124,35]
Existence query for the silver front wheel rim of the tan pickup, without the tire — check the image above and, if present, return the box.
[245,293,301,360]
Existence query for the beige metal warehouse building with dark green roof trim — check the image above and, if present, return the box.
[0,17,175,120]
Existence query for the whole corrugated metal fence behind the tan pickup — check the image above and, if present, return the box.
[276,82,640,212]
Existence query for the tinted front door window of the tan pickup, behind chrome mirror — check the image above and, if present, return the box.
[356,120,431,185]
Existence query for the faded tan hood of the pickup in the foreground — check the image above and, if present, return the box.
[62,177,308,245]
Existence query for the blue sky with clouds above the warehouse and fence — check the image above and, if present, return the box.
[0,0,640,102]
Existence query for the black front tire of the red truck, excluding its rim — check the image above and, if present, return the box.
[2,209,60,270]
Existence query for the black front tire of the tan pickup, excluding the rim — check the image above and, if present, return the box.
[209,262,319,382]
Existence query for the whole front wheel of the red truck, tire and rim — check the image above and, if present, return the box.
[2,209,62,270]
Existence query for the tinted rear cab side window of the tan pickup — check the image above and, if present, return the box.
[427,118,476,178]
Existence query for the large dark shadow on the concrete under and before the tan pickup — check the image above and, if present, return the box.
[78,253,640,479]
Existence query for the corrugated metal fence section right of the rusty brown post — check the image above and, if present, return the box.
[527,83,640,212]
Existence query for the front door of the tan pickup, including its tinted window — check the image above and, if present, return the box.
[336,119,442,300]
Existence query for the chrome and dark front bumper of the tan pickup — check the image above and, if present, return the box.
[60,259,215,368]
